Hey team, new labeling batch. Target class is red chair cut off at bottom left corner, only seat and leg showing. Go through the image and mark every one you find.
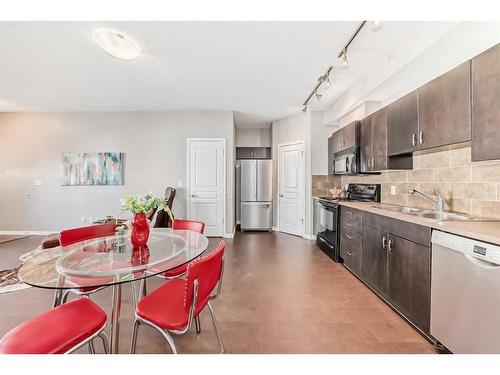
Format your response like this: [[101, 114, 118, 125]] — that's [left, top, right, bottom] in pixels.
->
[[0, 298, 109, 354]]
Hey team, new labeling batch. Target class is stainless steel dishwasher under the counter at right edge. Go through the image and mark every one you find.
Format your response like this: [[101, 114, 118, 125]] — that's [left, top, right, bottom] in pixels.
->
[[431, 230, 500, 353]]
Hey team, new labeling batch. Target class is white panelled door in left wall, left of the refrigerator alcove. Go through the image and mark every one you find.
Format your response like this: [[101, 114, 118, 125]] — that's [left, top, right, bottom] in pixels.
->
[[187, 139, 226, 237]]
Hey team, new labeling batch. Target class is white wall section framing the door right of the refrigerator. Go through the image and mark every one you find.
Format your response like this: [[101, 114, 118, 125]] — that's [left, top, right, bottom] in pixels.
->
[[272, 112, 312, 236]]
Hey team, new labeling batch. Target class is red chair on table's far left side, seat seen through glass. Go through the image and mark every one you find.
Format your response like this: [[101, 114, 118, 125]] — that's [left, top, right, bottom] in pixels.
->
[[60, 224, 116, 303]]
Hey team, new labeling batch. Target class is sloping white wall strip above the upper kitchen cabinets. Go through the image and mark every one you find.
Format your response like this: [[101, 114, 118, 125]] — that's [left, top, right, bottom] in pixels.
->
[[326, 22, 500, 123]]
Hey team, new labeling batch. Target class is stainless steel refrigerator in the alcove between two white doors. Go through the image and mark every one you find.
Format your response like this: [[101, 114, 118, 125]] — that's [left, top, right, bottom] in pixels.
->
[[240, 160, 273, 231]]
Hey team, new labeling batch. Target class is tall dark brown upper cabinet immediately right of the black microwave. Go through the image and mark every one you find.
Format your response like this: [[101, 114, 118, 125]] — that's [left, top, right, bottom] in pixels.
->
[[360, 107, 387, 172]]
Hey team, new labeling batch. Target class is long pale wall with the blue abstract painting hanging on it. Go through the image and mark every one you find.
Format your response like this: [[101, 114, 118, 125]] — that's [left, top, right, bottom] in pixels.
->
[[0, 112, 234, 233]]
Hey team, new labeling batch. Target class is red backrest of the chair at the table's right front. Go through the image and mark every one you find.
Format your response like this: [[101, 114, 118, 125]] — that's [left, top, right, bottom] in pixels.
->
[[184, 241, 226, 311]]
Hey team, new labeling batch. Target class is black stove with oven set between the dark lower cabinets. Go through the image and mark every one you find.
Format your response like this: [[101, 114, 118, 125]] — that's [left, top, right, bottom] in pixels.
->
[[314, 184, 380, 262]]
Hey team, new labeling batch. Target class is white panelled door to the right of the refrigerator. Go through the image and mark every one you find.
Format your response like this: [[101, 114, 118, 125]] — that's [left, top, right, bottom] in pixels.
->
[[278, 143, 305, 236]]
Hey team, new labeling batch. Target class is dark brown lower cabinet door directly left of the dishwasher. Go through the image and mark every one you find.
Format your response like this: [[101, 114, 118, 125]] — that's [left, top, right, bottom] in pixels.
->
[[388, 235, 431, 333]]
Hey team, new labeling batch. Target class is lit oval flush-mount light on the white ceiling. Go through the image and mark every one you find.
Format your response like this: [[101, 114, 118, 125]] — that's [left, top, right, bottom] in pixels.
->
[[94, 29, 141, 60]]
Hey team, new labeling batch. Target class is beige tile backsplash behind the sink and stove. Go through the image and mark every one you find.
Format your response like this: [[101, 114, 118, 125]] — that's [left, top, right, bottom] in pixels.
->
[[342, 147, 500, 219]]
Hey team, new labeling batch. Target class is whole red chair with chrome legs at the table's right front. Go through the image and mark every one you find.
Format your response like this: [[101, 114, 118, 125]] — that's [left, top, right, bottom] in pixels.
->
[[130, 241, 225, 354]]
